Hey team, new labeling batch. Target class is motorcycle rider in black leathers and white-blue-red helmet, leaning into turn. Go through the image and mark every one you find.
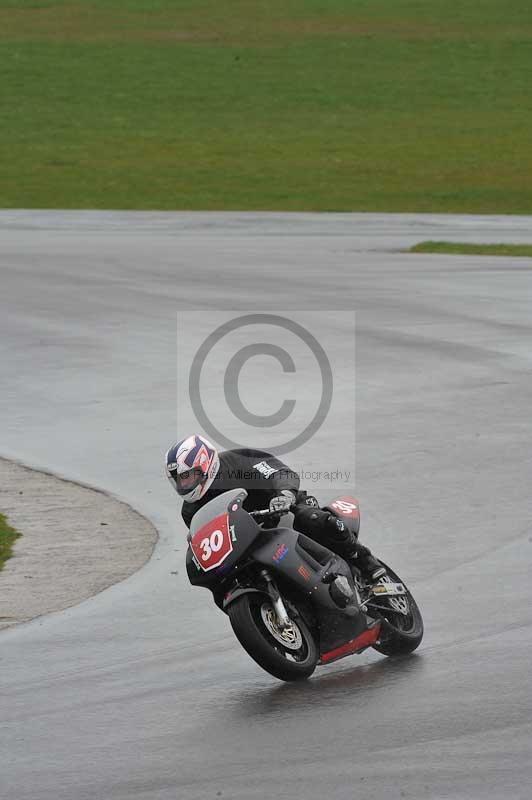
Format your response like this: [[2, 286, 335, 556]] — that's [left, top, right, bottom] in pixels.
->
[[166, 434, 386, 582]]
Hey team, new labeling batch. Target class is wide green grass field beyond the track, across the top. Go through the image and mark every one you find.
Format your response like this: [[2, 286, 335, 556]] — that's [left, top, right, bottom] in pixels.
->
[[0, 0, 532, 213]]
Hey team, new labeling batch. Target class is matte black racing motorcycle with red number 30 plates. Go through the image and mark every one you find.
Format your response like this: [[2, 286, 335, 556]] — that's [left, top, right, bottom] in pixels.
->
[[186, 489, 423, 681]]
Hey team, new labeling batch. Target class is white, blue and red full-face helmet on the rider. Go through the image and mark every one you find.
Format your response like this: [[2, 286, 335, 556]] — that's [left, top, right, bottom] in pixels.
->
[[166, 433, 220, 503]]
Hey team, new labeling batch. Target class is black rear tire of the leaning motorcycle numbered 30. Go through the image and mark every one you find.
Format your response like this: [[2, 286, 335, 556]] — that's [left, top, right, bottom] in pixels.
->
[[373, 565, 423, 656]]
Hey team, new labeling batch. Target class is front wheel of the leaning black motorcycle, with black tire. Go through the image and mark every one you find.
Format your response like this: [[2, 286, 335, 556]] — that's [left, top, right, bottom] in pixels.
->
[[227, 592, 319, 681]]
